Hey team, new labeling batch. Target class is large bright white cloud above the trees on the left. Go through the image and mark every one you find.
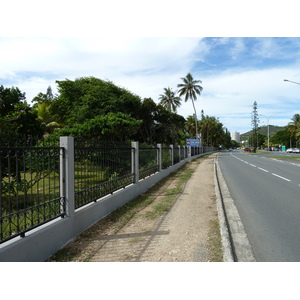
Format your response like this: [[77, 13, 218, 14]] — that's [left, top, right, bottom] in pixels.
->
[[0, 37, 204, 101]]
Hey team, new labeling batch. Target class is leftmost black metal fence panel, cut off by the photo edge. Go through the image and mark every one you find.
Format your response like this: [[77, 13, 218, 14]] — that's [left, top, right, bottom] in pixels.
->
[[0, 139, 65, 243]]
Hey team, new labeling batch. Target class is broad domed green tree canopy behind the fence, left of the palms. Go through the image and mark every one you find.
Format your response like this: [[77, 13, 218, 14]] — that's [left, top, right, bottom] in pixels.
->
[[51, 77, 185, 144]]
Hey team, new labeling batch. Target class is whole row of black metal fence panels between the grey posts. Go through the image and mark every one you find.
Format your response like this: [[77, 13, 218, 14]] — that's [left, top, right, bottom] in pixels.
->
[[0, 135, 214, 243]]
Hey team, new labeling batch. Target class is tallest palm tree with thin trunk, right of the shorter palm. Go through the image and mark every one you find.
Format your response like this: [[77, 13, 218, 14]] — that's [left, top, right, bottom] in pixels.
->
[[177, 73, 203, 144]]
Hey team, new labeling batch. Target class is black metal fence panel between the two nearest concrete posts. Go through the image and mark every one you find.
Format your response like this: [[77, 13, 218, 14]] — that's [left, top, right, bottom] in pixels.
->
[[74, 141, 134, 208]]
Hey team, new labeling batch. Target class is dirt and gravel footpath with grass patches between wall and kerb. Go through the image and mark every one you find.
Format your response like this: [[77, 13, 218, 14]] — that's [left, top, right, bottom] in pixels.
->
[[48, 156, 222, 262]]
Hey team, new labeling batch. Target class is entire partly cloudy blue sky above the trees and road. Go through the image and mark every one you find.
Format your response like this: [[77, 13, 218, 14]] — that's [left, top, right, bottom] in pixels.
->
[[0, 37, 300, 133]]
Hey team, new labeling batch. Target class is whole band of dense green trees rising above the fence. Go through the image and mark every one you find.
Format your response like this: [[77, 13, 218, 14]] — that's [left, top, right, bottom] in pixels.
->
[[0, 77, 230, 147]]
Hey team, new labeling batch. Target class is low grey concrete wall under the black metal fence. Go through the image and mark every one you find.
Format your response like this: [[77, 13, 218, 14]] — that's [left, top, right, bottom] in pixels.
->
[[0, 153, 207, 262]]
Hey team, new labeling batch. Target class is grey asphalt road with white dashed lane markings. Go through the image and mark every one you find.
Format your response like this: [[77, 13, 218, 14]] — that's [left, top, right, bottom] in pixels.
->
[[218, 151, 300, 262]]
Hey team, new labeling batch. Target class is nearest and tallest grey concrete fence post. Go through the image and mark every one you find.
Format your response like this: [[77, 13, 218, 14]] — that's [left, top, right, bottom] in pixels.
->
[[59, 136, 75, 218]]
